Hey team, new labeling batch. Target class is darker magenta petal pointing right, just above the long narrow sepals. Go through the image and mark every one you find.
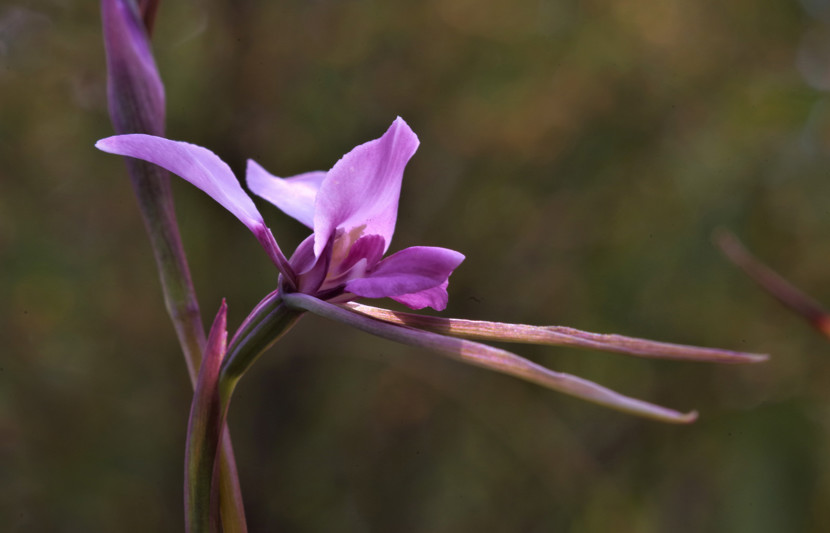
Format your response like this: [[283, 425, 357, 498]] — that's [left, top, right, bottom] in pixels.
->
[[346, 246, 464, 298]]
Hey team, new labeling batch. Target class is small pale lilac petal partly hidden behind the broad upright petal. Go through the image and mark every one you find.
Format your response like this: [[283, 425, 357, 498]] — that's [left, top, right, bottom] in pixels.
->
[[245, 159, 326, 229]]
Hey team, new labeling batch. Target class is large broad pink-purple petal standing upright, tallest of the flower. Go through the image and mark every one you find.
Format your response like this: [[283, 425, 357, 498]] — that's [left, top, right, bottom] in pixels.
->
[[314, 117, 418, 257]]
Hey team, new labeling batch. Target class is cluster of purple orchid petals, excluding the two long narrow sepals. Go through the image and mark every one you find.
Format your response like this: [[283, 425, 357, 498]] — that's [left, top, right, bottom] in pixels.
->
[[95, 117, 464, 311]]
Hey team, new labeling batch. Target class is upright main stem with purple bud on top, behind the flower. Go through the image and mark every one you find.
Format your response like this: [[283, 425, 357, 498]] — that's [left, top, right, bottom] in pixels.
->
[[101, 0, 247, 532]]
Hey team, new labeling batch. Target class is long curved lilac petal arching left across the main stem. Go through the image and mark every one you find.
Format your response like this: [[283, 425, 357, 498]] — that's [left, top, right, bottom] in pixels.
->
[[95, 134, 296, 284]]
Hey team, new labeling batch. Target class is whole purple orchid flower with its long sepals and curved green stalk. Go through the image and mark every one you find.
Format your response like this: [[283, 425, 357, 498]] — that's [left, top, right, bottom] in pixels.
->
[[96, 118, 766, 423]]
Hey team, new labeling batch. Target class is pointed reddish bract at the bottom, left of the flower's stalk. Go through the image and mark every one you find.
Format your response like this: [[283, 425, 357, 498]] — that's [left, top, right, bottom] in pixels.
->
[[184, 300, 228, 533]]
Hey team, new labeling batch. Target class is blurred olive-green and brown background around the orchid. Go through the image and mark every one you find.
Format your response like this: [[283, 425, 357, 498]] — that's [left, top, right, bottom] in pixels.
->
[[0, 0, 830, 533]]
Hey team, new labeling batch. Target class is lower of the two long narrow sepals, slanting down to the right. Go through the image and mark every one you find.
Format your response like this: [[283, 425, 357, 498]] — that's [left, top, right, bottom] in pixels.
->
[[283, 293, 697, 423]]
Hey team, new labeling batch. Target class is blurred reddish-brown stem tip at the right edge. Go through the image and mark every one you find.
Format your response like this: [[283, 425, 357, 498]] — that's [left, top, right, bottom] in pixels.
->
[[713, 230, 830, 338]]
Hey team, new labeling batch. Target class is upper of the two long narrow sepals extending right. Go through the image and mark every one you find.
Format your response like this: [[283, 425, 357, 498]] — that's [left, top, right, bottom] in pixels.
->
[[345, 303, 768, 363]]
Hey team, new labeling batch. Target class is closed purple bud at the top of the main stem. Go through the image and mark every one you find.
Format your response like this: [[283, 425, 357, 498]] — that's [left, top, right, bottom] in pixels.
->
[[101, 0, 165, 135]]
